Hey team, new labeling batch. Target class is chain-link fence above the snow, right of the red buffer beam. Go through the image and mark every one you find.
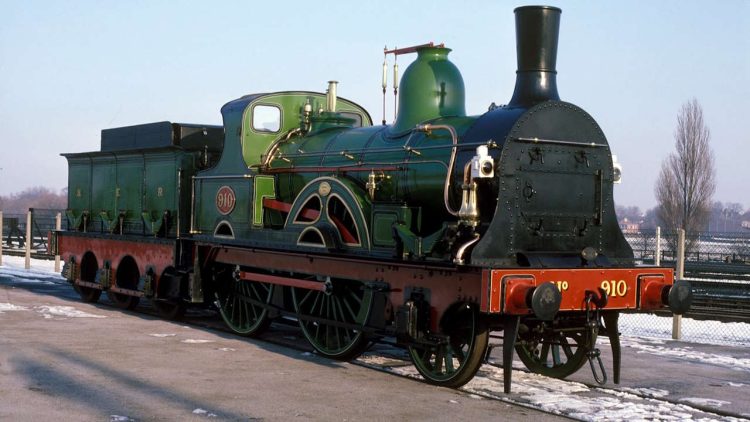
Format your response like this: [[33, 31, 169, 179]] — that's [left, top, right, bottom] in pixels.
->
[[620, 230, 750, 345]]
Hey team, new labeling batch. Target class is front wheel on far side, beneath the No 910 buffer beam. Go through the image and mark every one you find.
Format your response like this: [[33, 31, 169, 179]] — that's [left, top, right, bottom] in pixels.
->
[[516, 322, 596, 378]]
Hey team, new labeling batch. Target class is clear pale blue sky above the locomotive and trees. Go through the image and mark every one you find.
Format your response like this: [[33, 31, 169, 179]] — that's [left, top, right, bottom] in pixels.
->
[[0, 0, 750, 209]]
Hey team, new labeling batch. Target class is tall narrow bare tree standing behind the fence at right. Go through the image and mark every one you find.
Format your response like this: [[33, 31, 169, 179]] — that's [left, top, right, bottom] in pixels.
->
[[655, 98, 716, 244]]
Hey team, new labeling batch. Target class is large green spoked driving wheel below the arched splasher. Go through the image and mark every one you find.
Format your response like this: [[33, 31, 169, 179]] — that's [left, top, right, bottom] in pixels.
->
[[292, 280, 373, 360]]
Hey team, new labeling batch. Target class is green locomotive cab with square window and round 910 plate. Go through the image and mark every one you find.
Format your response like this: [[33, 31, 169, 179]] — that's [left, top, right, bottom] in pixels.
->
[[191, 90, 372, 240]]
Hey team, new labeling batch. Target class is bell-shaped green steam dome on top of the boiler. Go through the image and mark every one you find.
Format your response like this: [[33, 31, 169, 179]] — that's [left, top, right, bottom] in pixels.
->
[[393, 47, 466, 133]]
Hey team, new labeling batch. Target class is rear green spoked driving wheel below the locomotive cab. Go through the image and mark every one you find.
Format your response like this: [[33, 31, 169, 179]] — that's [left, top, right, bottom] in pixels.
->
[[216, 267, 274, 337]]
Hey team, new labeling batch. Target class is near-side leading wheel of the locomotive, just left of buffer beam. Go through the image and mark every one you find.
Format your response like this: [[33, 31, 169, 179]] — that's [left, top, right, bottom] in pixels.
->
[[409, 304, 489, 388]]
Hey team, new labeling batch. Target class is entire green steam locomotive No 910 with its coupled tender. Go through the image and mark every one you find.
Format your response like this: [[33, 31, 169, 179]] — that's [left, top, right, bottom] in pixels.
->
[[54, 6, 691, 391]]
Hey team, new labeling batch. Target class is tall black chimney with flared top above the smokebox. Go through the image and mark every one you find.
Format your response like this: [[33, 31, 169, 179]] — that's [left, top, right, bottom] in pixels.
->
[[508, 6, 562, 107]]
